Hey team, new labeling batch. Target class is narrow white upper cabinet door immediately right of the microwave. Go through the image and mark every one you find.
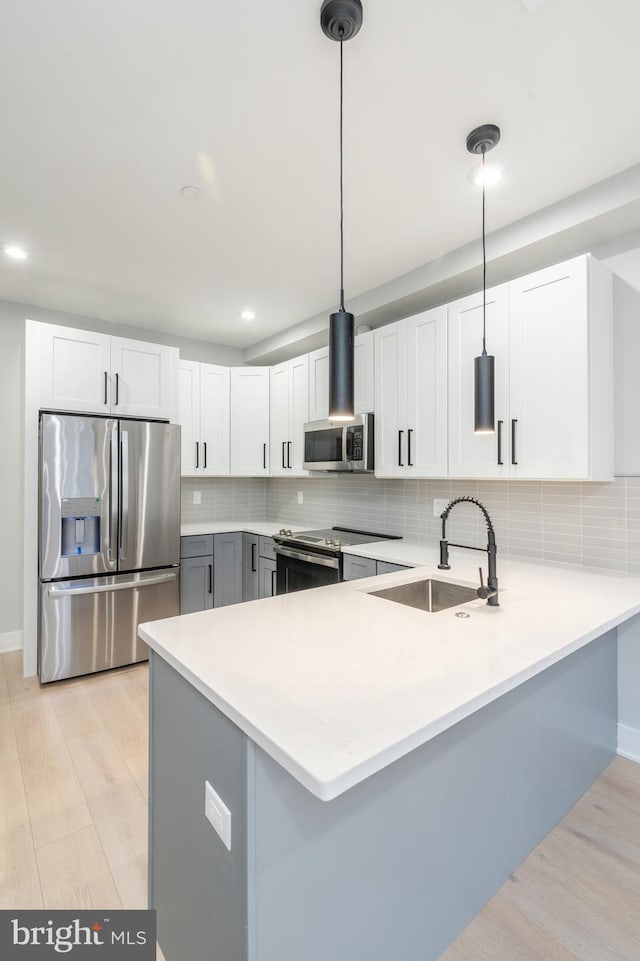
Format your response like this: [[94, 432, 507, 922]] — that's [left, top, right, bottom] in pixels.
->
[[375, 320, 407, 477]]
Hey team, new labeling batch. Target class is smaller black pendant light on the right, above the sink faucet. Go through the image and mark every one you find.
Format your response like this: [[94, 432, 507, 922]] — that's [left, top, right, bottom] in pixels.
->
[[467, 123, 500, 434]]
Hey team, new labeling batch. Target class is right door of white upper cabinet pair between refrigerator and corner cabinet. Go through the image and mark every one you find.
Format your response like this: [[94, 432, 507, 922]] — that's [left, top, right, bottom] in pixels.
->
[[200, 364, 229, 477]]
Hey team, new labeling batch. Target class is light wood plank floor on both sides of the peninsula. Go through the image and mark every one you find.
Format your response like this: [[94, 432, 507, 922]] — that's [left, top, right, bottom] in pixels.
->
[[0, 652, 640, 961]]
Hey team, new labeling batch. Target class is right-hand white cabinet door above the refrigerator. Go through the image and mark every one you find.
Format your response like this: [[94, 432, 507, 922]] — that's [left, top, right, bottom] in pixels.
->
[[111, 337, 178, 419]]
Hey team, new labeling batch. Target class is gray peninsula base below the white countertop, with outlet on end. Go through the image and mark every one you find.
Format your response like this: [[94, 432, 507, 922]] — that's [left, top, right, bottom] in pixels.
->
[[149, 631, 617, 961]]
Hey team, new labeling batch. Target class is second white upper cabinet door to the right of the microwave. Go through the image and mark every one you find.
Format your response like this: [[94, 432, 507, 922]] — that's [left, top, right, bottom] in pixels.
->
[[403, 306, 447, 477]]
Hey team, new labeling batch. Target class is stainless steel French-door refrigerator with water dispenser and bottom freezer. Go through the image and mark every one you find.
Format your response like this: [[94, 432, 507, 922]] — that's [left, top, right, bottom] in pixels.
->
[[38, 413, 180, 683]]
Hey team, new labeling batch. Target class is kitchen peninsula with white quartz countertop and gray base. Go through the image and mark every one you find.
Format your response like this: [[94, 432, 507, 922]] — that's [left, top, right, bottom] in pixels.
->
[[140, 542, 640, 961]]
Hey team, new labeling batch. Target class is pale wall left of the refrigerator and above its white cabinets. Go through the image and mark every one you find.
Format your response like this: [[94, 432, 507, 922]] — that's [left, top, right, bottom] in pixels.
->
[[0, 300, 243, 651]]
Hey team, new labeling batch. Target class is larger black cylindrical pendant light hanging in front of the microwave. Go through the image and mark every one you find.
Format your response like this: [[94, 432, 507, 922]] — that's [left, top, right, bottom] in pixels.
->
[[320, 0, 362, 420]]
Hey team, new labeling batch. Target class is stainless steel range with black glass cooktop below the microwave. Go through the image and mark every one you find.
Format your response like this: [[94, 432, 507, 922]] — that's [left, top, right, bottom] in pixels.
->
[[274, 527, 400, 594]]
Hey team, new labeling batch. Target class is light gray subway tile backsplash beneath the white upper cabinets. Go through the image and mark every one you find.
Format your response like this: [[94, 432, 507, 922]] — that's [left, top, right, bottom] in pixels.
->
[[182, 474, 640, 574]]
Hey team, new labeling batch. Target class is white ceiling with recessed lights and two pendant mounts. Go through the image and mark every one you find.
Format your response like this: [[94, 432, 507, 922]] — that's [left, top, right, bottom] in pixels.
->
[[0, 0, 640, 347]]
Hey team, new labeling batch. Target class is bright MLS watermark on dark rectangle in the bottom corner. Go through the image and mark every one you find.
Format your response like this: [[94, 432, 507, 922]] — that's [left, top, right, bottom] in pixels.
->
[[0, 910, 156, 961]]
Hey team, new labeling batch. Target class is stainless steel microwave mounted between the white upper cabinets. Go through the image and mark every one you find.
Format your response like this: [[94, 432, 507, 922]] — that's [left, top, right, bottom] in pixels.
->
[[302, 414, 374, 472]]
